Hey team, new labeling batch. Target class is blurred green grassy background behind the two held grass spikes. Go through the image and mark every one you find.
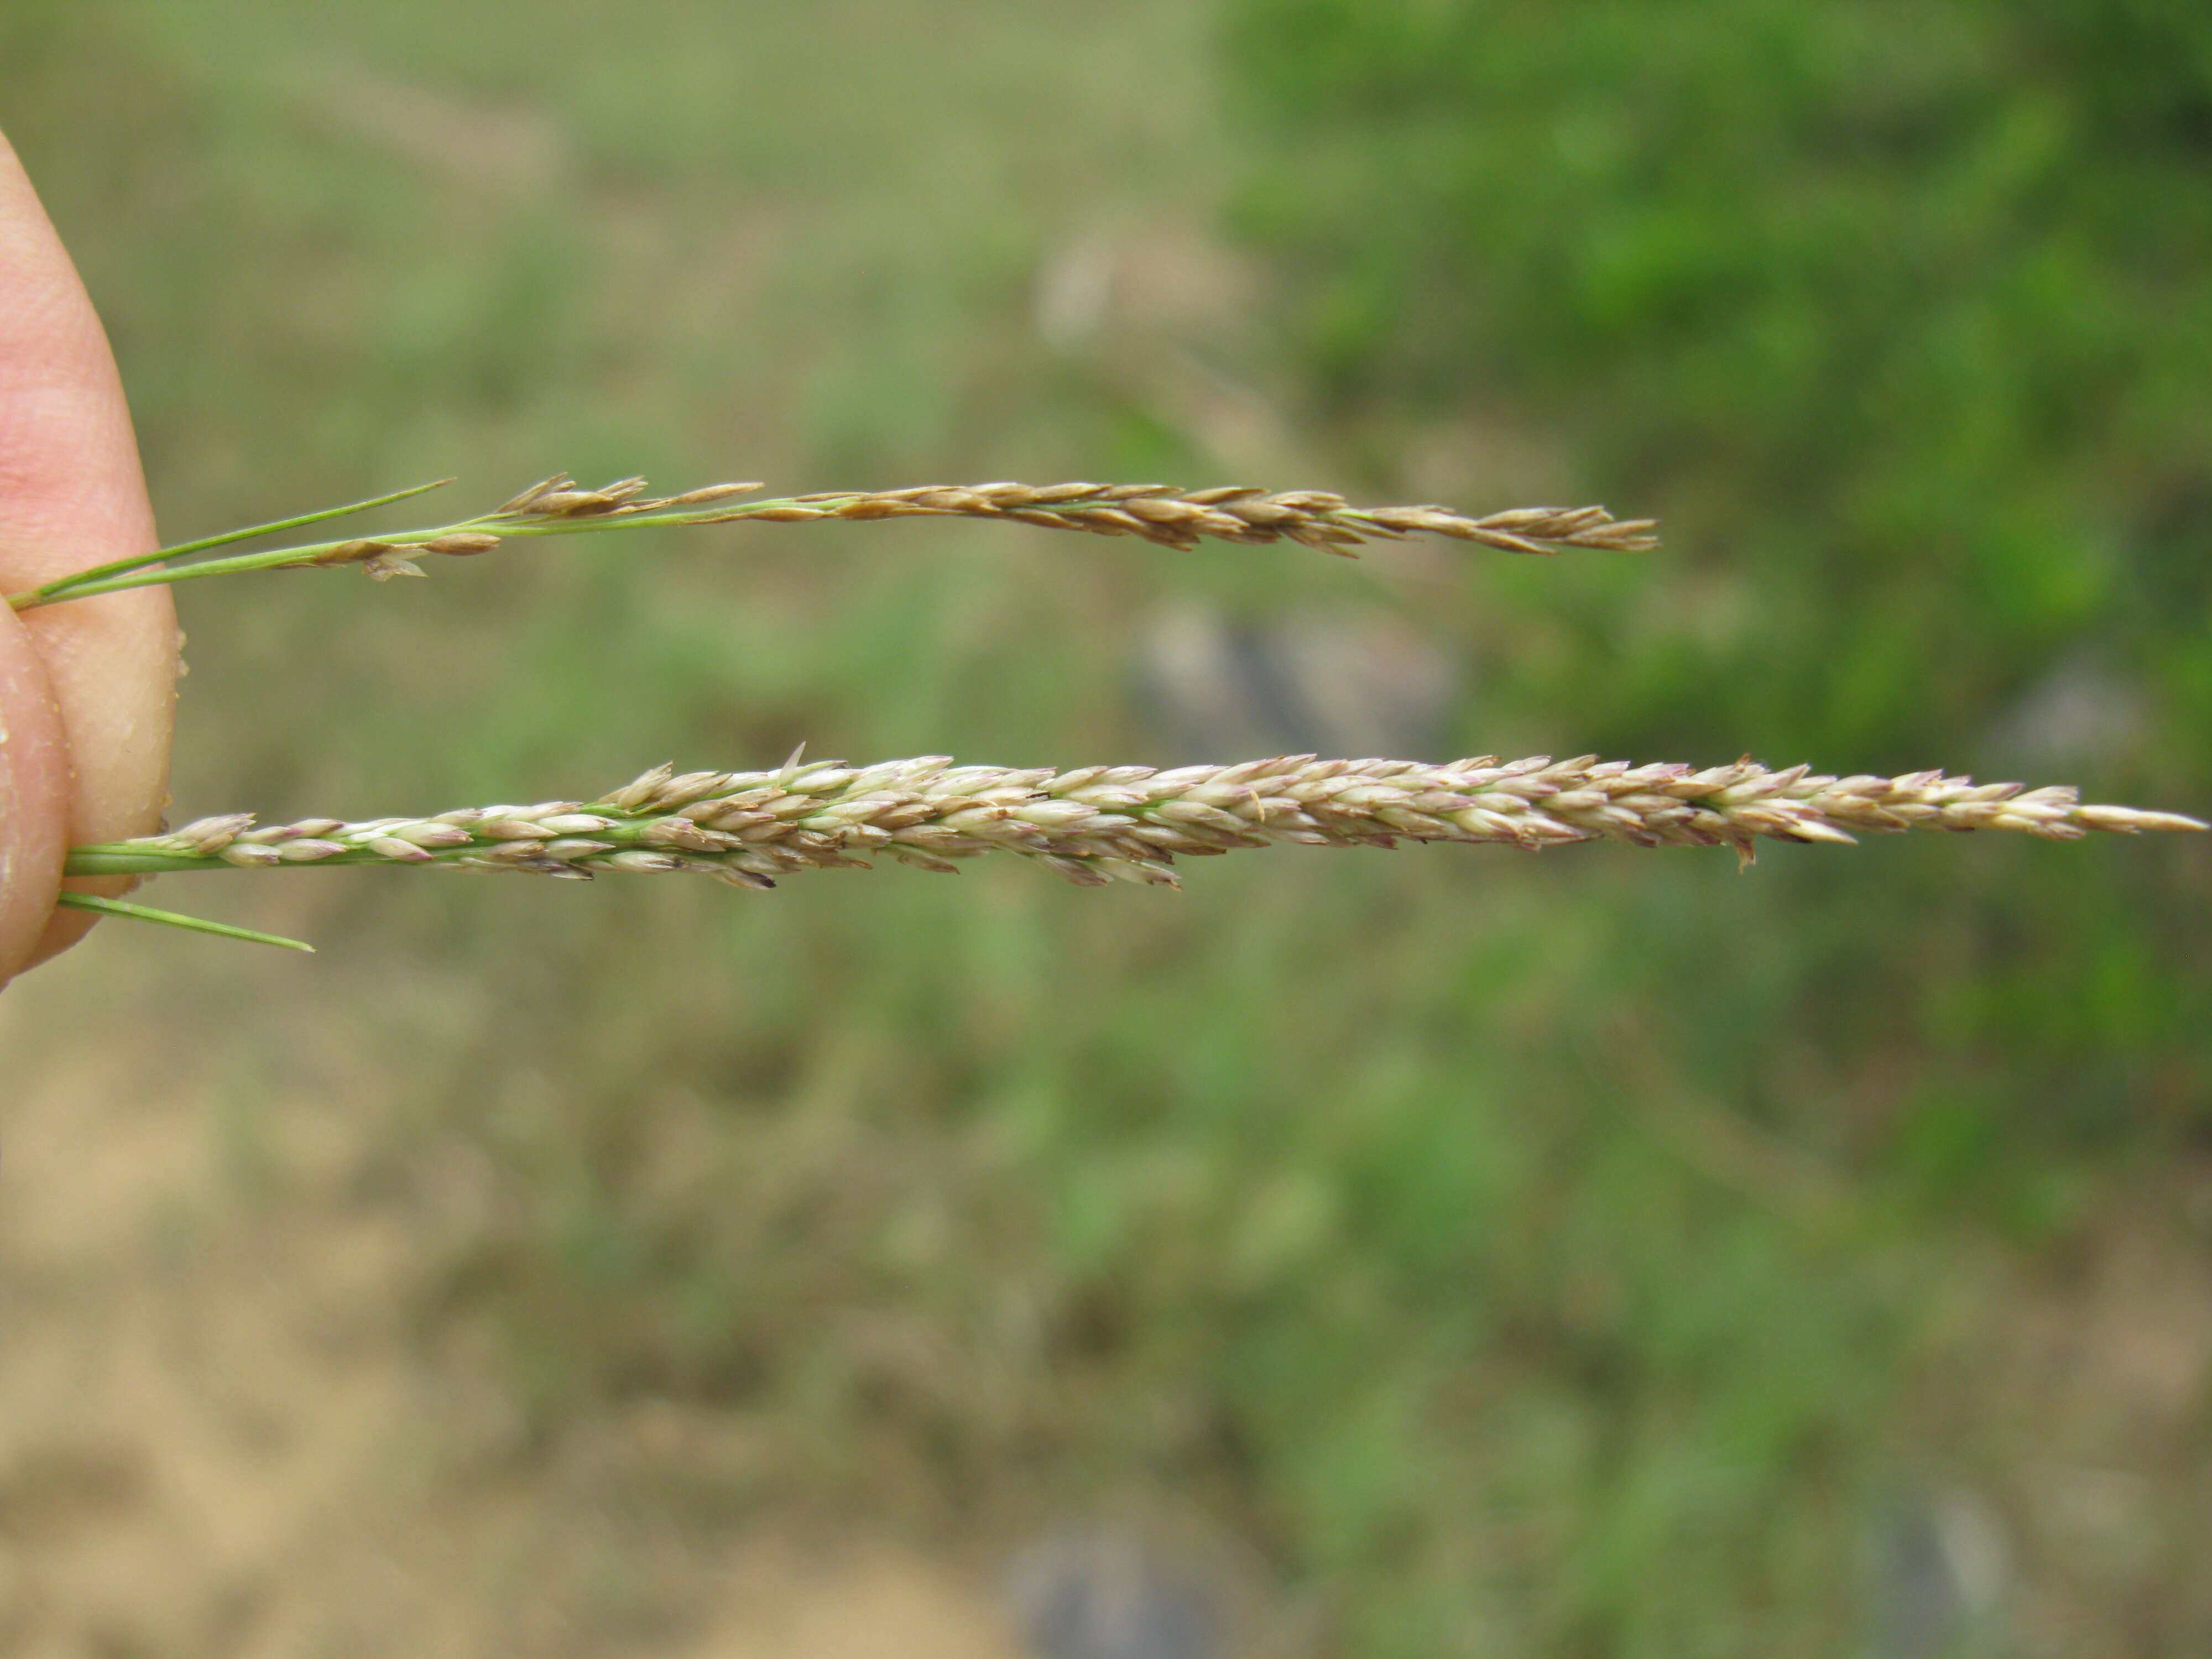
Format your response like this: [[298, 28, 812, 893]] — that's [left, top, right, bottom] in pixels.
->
[[0, 0, 2212, 1657]]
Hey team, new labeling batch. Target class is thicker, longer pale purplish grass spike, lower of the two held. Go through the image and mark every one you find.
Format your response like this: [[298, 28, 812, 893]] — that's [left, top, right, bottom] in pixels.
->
[[69, 754, 2205, 902]]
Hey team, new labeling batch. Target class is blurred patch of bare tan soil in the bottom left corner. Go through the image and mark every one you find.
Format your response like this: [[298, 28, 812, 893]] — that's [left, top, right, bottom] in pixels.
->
[[0, 980, 1020, 1659]]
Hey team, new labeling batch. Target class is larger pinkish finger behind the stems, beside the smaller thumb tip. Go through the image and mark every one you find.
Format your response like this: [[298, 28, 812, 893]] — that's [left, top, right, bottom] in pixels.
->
[[0, 137, 177, 982]]
